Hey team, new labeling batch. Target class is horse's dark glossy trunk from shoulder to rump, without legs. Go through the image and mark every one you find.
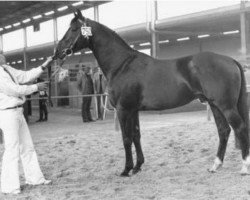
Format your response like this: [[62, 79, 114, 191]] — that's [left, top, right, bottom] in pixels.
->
[[110, 52, 240, 110]]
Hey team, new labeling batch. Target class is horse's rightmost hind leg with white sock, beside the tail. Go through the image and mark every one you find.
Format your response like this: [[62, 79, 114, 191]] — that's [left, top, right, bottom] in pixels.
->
[[225, 109, 250, 175]]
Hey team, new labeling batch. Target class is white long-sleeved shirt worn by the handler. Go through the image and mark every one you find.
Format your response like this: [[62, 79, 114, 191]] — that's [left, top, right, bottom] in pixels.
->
[[0, 65, 43, 110]]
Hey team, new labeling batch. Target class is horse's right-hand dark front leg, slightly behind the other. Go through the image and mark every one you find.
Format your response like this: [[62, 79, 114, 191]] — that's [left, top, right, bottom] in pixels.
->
[[133, 112, 144, 174]]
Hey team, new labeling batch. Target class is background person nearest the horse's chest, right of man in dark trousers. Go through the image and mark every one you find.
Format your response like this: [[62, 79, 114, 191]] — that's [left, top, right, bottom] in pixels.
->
[[93, 67, 107, 119]]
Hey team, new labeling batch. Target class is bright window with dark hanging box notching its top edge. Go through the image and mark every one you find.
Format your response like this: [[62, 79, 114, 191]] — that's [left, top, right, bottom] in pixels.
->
[[27, 20, 54, 47]]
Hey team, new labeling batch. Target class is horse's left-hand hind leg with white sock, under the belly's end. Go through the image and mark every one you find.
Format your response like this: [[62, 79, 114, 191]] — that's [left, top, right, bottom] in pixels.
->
[[209, 104, 231, 172]]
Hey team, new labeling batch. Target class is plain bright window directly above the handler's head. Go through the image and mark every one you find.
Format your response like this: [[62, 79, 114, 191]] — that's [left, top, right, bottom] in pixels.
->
[[3, 29, 24, 51]]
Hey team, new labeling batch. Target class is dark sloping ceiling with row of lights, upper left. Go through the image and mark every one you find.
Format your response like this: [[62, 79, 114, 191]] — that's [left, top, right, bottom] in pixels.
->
[[0, 1, 109, 34]]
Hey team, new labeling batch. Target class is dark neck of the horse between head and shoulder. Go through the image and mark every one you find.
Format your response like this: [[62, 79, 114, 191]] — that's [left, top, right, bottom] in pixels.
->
[[89, 25, 134, 79]]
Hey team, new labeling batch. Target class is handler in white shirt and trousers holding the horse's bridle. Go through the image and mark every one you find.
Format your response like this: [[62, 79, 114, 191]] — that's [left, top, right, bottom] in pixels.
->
[[0, 54, 52, 194]]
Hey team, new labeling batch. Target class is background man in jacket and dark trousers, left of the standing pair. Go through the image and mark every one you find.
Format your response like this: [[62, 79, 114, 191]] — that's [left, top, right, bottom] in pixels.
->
[[77, 65, 94, 122]]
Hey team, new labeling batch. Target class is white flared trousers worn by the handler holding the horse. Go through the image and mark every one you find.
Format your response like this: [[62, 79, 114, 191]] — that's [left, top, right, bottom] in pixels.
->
[[0, 108, 45, 193]]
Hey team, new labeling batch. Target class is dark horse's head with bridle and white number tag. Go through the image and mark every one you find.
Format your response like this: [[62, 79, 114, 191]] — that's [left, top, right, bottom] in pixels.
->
[[54, 9, 92, 60]]
